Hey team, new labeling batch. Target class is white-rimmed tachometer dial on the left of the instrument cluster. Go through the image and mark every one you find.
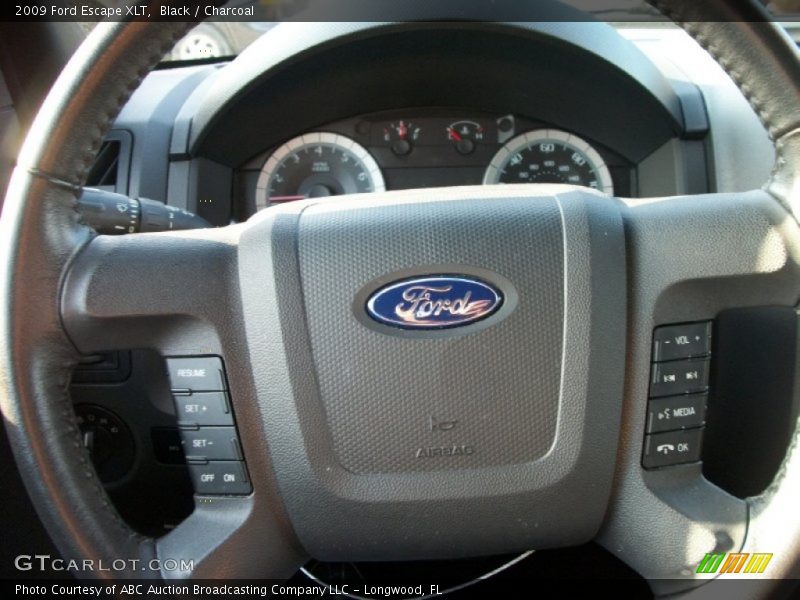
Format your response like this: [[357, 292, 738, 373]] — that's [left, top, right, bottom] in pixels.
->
[[256, 132, 385, 210]]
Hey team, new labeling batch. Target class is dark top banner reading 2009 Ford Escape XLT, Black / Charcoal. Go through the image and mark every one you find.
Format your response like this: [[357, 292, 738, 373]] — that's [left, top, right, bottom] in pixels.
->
[[0, 0, 800, 23]]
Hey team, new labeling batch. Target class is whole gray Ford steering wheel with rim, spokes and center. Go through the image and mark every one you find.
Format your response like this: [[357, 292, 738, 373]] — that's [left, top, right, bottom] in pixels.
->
[[0, 0, 800, 596]]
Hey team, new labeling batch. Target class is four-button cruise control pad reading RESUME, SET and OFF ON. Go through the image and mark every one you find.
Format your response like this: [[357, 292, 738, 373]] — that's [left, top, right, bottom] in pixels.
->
[[167, 356, 252, 495]]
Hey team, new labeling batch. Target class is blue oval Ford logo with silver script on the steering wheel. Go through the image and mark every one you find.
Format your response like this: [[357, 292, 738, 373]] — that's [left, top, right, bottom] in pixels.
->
[[367, 275, 503, 329]]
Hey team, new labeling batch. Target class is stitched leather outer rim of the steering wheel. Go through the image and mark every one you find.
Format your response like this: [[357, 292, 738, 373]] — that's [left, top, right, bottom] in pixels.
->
[[0, 0, 800, 594]]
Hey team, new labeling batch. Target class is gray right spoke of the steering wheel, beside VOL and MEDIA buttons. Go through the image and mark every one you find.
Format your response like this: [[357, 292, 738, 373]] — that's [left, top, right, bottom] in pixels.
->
[[598, 191, 800, 594]]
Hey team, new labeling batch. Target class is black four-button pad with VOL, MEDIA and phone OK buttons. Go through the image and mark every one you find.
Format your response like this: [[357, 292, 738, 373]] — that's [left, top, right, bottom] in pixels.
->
[[642, 321, 712, 469]]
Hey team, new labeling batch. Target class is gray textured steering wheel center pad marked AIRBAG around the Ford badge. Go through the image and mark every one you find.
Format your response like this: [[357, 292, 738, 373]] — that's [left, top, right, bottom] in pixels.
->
[[240, 186, 625, 560]]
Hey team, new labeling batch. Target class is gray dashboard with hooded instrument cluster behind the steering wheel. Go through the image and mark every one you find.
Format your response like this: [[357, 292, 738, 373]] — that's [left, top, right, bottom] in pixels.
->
[[106, 22, 772, 225]]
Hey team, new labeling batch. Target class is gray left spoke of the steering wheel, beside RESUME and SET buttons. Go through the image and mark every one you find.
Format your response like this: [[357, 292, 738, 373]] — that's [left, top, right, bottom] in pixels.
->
[[61, 227, 304, 579]]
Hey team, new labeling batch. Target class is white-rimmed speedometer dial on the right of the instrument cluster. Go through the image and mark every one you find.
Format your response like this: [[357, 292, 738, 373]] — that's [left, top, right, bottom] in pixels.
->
[[483, 129, 614, 195]]
